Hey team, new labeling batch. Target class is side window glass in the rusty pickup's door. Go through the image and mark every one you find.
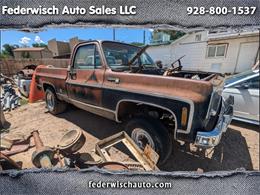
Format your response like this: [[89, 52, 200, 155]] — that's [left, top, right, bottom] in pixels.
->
[[74, 44, 102, 69]]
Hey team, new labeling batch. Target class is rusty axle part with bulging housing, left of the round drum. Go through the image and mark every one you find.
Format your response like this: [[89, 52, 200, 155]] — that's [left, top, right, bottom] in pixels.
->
[[32, 130, 54, 168]]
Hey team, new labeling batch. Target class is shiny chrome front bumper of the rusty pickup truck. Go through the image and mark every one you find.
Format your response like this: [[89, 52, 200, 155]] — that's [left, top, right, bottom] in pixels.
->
[[195, 96, 234, 148]]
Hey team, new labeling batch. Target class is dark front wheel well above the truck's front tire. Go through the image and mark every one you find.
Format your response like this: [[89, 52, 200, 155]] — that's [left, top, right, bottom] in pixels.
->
[[116, 101, 177, 133]]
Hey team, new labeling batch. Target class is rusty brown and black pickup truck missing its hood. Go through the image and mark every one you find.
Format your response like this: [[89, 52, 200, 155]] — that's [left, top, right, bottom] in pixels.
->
[[36, 41, 233, 164]]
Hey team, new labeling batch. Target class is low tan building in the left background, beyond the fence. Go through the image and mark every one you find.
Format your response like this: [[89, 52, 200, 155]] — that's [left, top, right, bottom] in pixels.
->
[[13, 47, 52, 59]]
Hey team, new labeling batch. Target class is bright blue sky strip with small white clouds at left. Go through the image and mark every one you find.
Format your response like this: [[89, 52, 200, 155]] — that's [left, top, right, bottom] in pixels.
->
[[1, 27, 151, 46]]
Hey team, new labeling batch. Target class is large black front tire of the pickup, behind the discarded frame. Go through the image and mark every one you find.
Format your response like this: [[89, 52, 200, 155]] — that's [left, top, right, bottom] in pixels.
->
[[125, 117, 172, 166]]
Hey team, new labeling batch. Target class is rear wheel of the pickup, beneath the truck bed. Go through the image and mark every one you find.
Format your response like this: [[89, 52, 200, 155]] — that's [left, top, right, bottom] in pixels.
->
[[45, 88, 67, 115]]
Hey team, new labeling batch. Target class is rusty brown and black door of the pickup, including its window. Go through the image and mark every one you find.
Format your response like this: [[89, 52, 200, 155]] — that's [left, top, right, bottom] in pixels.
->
[[66, 43, 104, 106]]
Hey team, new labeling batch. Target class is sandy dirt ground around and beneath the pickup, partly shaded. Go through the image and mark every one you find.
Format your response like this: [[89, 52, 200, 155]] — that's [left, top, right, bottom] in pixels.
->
[[1, 102, 259, 171]]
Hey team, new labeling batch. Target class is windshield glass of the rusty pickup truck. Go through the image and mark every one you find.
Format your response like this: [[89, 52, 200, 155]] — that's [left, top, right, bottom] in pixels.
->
[[102, 42, 156, 70]]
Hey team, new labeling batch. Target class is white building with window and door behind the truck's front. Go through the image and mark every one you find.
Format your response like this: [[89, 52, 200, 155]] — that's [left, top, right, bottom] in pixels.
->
[[147, 31, 259, 73]]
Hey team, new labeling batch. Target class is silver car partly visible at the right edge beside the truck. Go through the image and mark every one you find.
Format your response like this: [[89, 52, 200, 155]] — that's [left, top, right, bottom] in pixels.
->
[[223, 69, 260, 125]]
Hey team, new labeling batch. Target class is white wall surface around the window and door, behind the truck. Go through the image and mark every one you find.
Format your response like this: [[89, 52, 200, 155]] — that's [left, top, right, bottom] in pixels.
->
[[147, 31, 259, 73]]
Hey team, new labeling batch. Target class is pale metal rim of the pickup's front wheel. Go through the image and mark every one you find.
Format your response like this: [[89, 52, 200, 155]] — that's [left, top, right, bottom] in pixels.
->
[[131, 128, 155, 150]]
